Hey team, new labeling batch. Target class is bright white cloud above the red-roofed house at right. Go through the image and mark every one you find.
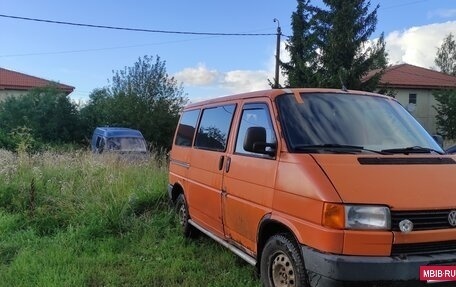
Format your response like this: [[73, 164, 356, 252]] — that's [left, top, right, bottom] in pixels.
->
[[385, 21, 456, 68]]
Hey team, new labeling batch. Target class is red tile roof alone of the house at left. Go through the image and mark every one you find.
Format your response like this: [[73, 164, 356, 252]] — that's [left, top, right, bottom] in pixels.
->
[[0, 68, 74, 94]]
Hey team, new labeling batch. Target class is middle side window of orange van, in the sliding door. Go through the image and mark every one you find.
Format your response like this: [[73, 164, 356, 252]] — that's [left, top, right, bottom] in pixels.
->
[[195, 104, 236, 151]]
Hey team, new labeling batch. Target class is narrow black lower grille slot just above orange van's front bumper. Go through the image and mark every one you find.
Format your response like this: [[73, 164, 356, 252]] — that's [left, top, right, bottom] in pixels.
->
[[391, 241, 456, 256]]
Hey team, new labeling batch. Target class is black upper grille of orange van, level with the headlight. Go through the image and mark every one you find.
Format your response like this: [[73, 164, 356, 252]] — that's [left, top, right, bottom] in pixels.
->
[[391, 209, 454, 231]]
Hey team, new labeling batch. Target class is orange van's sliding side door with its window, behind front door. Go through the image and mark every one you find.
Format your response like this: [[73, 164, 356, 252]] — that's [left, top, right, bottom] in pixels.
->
[[187, 104, 236, 237]]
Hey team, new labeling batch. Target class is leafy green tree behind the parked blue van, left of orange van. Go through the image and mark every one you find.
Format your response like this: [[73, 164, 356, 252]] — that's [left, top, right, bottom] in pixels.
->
[[81, 56, 187, 151]]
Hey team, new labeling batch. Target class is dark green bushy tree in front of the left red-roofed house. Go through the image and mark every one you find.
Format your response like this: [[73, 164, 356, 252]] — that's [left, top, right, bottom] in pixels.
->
[[0, 86, 81, 146]]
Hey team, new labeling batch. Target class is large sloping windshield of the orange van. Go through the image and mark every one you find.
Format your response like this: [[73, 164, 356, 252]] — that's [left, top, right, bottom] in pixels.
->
[[276, 93, 443, 154]]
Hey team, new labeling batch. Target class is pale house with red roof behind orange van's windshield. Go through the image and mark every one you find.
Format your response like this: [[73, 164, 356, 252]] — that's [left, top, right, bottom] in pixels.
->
[[365, 64, 456, 134]]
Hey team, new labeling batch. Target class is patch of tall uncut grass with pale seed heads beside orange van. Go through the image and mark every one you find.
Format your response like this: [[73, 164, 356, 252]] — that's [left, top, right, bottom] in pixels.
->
[[0, 151, 166, 235]]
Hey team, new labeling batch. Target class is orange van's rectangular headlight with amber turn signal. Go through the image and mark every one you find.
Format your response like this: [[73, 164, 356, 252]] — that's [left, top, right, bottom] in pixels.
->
[[322, 203, 391, 230]]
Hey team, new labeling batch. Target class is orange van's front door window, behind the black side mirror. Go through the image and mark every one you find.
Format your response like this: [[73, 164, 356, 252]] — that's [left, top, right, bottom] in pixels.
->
[[234, 103, 277, 156]]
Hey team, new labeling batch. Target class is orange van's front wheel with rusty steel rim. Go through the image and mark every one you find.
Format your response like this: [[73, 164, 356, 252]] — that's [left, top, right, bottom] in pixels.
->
[[260, 234, 310, 287]]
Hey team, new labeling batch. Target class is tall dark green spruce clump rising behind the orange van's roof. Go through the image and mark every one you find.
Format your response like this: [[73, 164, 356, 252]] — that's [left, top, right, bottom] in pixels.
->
[[283, 0, 387, 91]]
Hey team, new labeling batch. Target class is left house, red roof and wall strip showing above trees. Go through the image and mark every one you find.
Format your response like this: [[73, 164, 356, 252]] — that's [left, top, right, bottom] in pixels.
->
[[0, 68, 74, 101]]
